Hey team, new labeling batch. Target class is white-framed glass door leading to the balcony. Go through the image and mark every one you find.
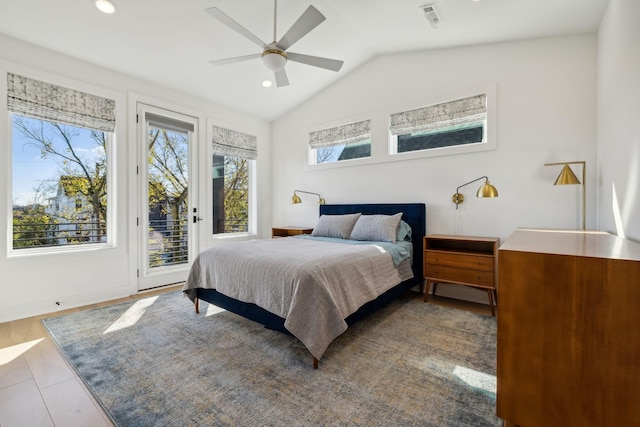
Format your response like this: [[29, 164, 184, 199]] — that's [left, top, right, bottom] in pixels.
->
[[138, 105, 198, 290]]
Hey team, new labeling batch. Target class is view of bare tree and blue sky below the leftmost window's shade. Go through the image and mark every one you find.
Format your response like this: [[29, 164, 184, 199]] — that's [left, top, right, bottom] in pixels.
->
[[12, 114, 111, 249]]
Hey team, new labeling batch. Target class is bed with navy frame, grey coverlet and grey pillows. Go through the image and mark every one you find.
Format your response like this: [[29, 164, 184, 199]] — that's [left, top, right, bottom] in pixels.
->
[[183, 203, 426, 368]]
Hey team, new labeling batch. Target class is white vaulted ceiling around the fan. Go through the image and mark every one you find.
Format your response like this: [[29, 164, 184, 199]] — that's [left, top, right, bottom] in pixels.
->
[[0, 0, 608, 121]]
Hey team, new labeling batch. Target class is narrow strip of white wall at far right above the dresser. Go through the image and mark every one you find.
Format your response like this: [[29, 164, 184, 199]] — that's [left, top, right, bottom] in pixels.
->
[[598, 0, 640, 241]]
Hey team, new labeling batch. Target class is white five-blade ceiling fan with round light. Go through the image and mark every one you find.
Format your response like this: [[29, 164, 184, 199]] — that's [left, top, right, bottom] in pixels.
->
[[205, 0, 344, 87]]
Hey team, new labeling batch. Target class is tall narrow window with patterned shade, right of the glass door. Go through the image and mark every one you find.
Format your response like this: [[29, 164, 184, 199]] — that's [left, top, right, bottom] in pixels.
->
[[212, 126, 258, 234]]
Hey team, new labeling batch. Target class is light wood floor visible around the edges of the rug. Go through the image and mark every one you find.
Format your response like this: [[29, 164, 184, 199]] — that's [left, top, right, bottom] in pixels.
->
[[0, 285, 491, 427]]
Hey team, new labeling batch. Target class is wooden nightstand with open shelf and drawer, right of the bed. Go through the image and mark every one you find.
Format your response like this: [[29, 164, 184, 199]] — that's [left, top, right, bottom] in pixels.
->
[[423, 234, 500, 316]]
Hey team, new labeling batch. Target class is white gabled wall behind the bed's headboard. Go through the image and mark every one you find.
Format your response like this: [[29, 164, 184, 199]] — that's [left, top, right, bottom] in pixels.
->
[[273, 35, 597, 301]]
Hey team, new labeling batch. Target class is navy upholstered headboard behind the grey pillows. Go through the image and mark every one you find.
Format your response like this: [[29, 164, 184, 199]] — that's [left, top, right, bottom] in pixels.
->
[[320, 203, 427, 283]]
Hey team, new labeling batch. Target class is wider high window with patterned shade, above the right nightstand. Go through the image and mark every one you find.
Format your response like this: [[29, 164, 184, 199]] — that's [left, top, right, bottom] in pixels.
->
[[390, 94, 487, 154]]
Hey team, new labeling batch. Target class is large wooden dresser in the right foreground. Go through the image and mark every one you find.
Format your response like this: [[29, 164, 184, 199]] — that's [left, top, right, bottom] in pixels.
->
[[497, 229, 640, 427]]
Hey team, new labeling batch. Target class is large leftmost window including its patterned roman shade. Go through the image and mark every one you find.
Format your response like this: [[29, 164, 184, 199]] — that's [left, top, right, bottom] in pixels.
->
[[7, 73, 115, 250]]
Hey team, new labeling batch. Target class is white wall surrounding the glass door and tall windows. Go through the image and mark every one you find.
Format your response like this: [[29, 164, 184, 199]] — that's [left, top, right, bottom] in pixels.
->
[[0, 35, 271, 322]]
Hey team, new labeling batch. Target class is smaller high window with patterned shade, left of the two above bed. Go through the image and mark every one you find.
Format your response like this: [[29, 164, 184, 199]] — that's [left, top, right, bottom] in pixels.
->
[[309, 120, 371, 164]]
